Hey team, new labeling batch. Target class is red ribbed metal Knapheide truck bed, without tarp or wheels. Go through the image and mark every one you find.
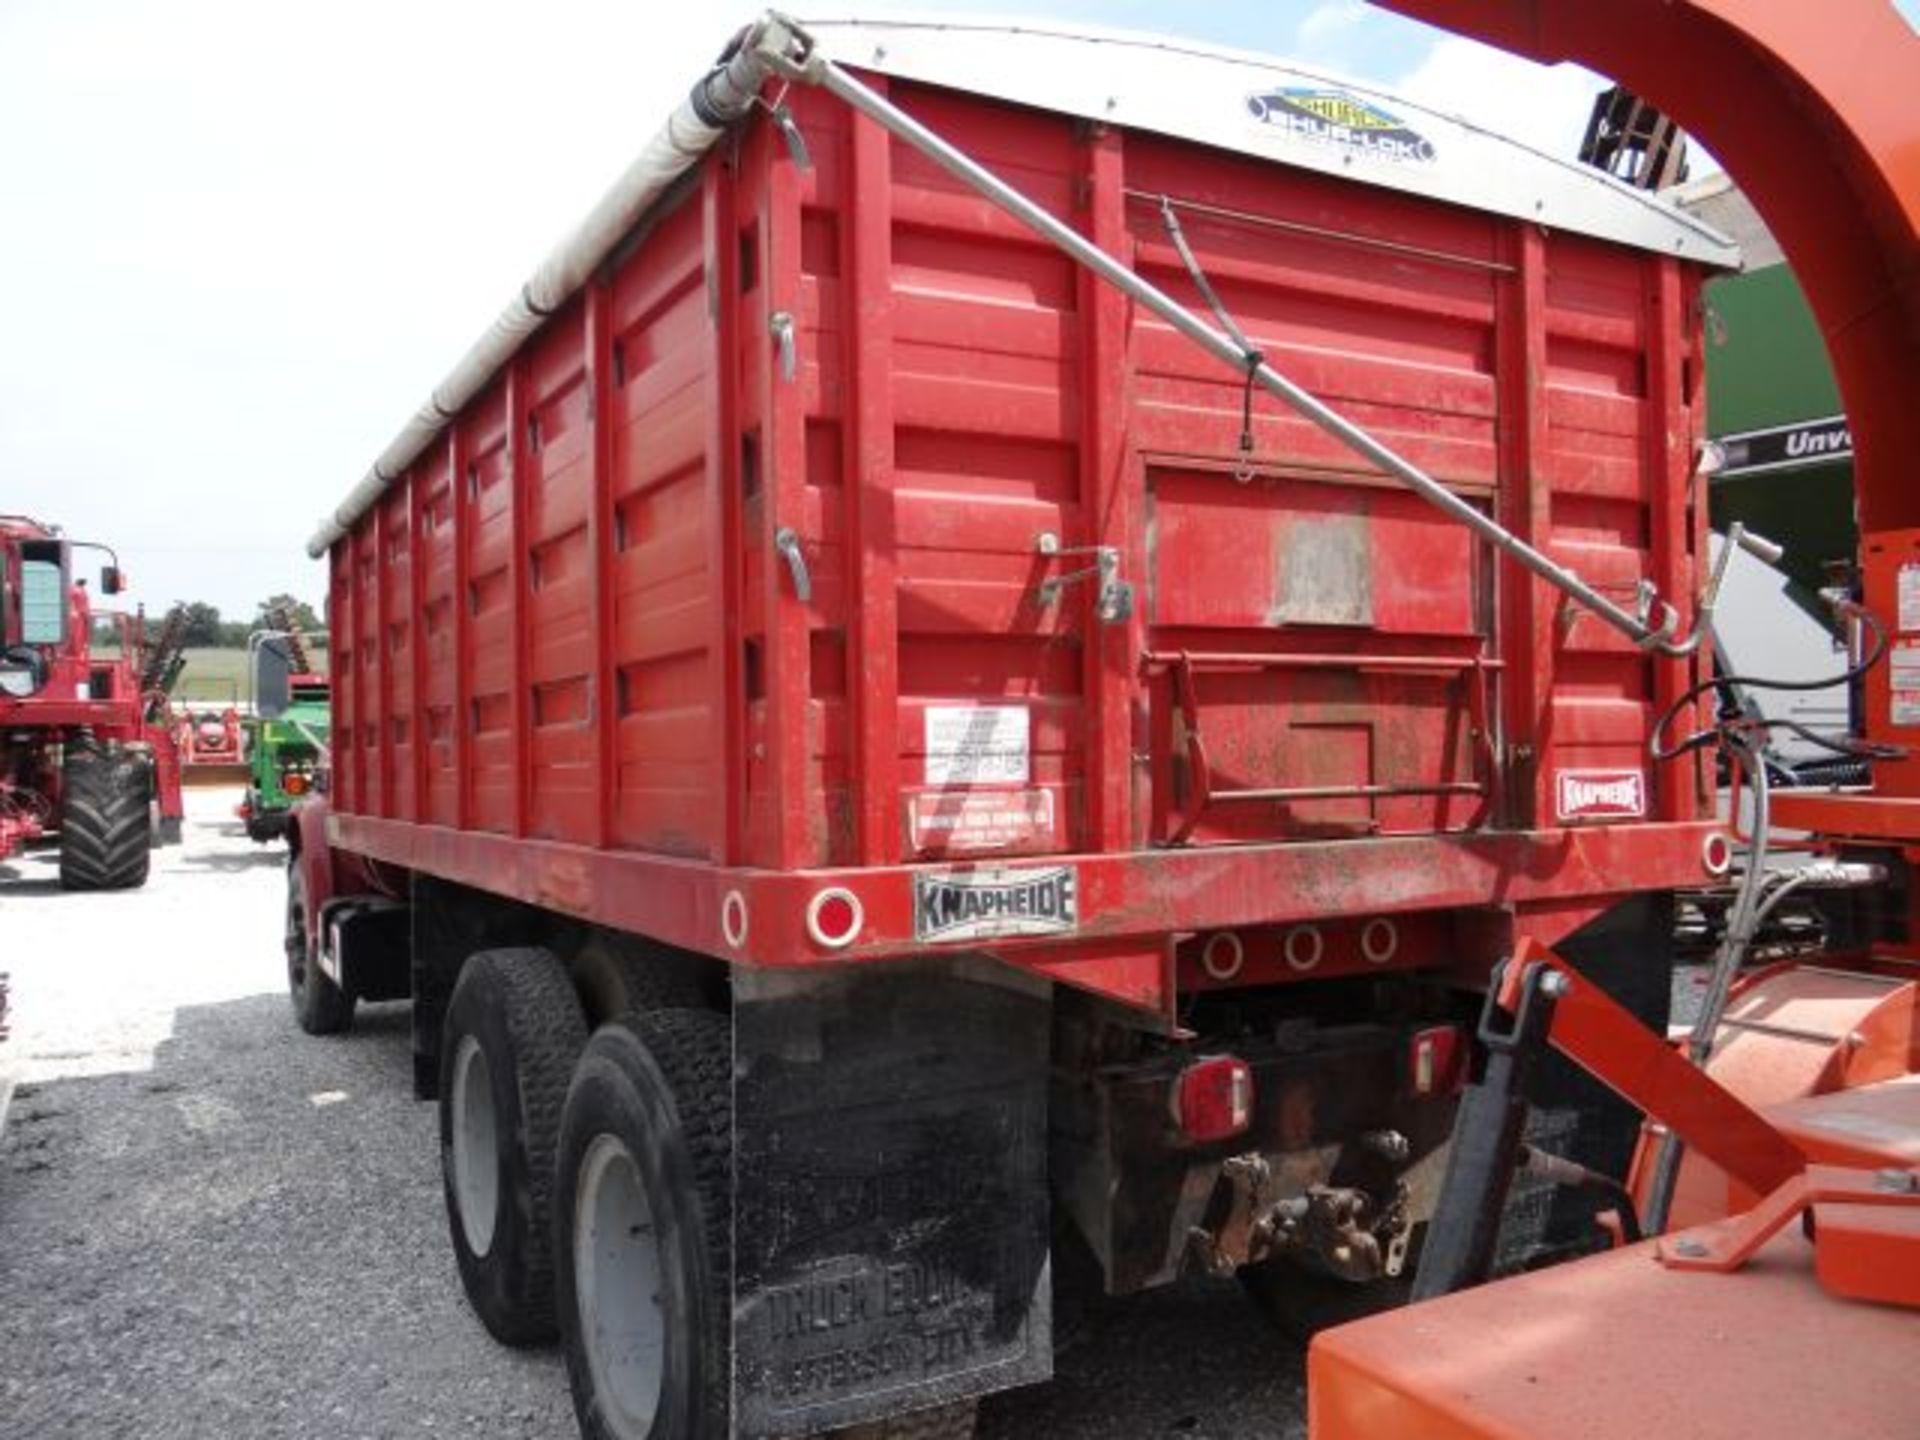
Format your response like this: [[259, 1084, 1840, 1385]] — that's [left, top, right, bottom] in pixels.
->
[[311, 16, 1728, 1006]]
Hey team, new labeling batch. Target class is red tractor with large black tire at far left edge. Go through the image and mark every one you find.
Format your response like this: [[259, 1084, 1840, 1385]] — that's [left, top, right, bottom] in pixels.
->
[[0, 515, 180, 891]]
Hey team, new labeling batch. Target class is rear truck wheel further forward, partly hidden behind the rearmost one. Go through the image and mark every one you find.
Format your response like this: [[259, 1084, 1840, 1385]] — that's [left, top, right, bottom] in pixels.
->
[[440, 947, 588, 1346]]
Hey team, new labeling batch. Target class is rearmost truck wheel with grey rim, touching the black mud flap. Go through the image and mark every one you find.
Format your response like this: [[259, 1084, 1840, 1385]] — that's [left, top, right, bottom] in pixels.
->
[[553, 1010, 733, 1440]]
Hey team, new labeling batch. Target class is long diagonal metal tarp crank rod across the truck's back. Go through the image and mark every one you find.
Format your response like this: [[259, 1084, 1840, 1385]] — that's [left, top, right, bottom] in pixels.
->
[[756, 13, 1780, 659]]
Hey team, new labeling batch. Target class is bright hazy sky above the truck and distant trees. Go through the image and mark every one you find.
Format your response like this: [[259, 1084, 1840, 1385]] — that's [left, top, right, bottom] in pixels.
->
[[0, 0, 1920, 618]]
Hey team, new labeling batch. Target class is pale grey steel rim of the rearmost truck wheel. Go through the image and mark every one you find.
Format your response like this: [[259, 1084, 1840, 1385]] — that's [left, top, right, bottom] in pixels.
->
[[574, 1135, 666, 1440]]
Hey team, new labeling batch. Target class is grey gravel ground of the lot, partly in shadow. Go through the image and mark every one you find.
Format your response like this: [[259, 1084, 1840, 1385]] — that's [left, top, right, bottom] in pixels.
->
[[0, 791, 1304, 1440]]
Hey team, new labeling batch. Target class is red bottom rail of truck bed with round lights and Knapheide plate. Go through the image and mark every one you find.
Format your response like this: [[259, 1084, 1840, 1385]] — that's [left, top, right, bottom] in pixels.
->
[[326, 812, 1718, 1010]]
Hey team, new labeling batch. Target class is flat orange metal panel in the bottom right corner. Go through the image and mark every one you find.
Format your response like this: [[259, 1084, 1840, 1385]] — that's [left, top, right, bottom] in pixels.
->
[[1308, 1227, 1920, 1440]]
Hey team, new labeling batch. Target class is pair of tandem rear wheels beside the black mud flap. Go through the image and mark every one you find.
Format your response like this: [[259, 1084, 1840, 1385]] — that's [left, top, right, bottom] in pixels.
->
[[440, 948, 973, 1440]]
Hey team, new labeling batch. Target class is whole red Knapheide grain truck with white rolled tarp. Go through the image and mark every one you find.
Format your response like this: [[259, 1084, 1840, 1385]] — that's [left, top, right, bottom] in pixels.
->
[[286, 17, 1736, 1436]]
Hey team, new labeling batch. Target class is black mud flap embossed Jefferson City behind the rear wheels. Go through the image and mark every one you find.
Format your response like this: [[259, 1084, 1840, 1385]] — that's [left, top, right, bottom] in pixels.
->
[[733, 960, 1052, 1436]]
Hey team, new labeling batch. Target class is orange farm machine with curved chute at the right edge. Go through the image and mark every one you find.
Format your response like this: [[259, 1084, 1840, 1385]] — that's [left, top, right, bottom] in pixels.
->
[[1309, 0, 1920, 1440]]
